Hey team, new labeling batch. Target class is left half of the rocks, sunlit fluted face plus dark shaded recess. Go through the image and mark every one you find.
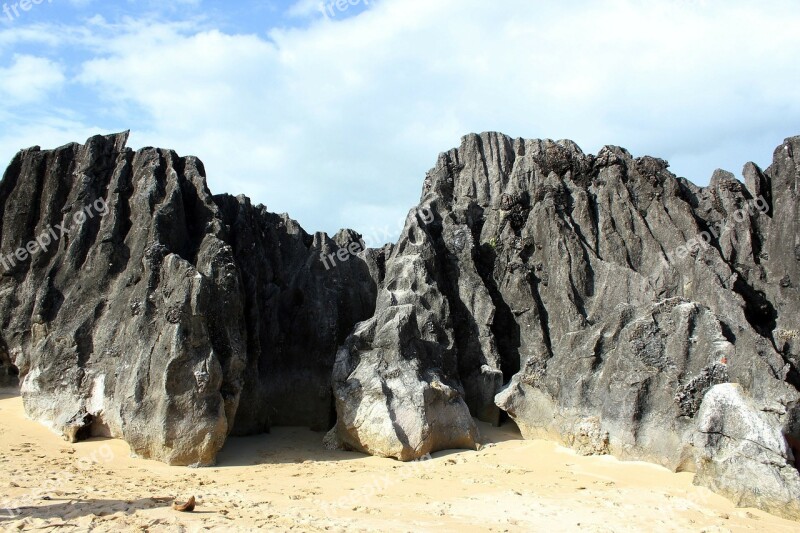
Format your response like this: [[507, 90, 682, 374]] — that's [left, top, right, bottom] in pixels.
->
[[0, 134, 374, 465]]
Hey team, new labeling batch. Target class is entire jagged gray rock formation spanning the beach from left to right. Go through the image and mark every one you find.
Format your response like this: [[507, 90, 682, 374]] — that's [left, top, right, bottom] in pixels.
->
[[0, 133, 800, 519]]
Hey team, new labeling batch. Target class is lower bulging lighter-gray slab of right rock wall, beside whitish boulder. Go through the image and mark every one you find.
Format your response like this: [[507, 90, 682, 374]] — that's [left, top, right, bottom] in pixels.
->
[[497, 298, 796, 471]]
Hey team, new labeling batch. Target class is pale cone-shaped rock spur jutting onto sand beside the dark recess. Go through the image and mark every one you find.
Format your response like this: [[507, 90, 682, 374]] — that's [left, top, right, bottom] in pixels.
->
[[333, 216, 477, 461]]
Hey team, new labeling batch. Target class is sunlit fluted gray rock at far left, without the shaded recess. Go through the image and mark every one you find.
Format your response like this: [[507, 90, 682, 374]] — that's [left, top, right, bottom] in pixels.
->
[[0, 134, 245, 464]]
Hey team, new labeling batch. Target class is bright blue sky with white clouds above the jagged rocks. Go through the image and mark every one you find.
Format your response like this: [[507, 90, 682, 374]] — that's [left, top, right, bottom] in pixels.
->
[[0, 0, 800, 246]]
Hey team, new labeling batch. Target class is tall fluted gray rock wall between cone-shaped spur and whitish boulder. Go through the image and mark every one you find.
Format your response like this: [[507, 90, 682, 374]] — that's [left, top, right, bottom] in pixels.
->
[[386, 133, 800, 516]]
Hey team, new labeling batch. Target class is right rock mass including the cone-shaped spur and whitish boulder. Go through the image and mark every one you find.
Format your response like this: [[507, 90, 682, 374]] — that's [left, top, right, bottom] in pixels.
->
[[326, 134, 800, 518]]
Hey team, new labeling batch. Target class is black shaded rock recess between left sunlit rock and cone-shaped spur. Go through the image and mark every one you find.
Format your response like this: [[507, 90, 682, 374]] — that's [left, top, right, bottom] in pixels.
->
[[215, 196, 378, 435]]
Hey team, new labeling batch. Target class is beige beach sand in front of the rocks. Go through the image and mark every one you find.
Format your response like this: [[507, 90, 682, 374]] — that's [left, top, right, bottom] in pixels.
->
[[0, 391, 800, 532]]
